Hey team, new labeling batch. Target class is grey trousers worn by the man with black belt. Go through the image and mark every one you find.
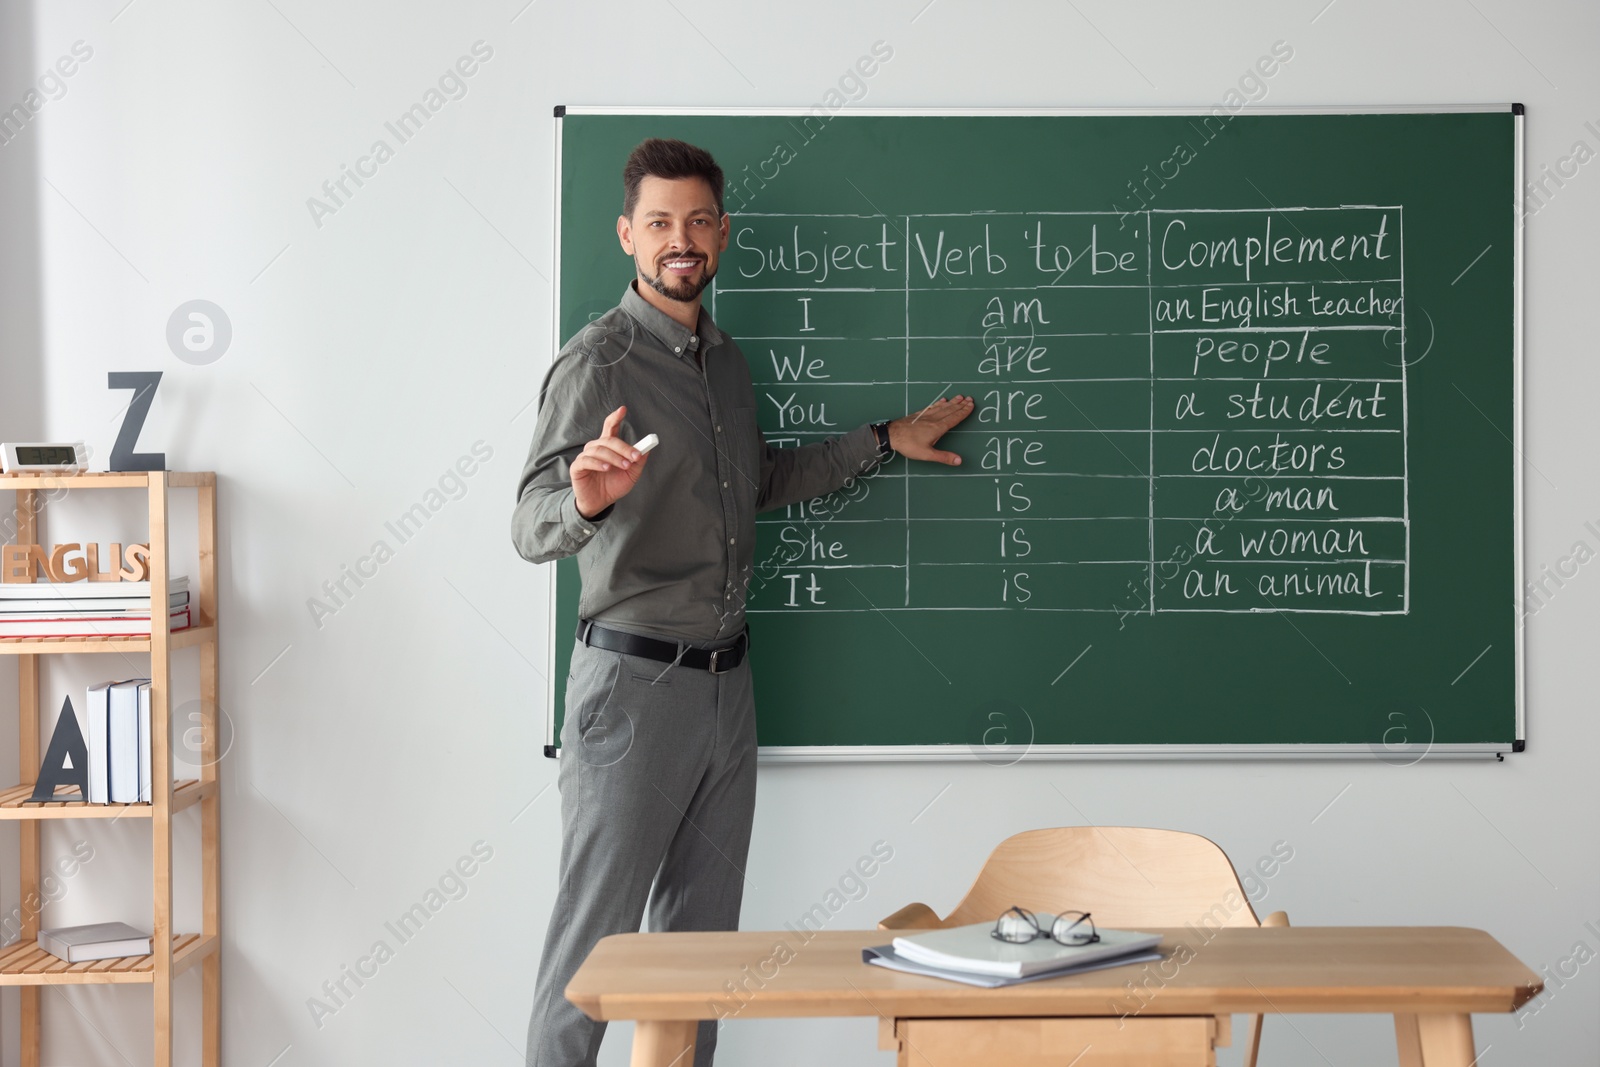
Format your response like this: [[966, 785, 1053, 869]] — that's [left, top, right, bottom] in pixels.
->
[[528, 643, 755, 1067]]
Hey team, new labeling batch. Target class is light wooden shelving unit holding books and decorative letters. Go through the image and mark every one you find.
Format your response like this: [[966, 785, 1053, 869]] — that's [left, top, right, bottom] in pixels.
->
[[0, 470, 222, 1067]]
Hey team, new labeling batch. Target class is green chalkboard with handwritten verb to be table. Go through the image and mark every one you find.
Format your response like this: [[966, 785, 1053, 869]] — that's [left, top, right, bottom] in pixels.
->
[[549, 106, 1523, 761]]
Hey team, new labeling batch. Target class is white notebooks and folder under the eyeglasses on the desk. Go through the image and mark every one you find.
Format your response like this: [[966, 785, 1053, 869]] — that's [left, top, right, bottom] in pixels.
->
[[861, 915, 1162, 989]]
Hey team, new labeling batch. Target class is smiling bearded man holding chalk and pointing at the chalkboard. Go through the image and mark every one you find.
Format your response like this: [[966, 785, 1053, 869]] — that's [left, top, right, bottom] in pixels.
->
[[512, 139, 973, 1067]]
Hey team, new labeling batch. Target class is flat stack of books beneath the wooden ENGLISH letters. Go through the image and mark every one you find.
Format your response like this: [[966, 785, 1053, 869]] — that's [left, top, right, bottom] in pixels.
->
[[0, 577, 189, 637]]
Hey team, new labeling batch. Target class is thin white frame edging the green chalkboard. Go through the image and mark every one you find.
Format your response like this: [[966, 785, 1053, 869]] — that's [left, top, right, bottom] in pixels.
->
[[544, 104, 1528, 765]]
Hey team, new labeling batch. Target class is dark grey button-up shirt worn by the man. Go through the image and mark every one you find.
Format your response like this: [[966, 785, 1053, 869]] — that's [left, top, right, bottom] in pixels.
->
[[512, 283, 878, 645]]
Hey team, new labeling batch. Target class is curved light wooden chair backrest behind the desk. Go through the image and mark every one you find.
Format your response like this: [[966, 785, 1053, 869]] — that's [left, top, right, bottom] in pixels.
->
[[941, 825, 1261, 929]]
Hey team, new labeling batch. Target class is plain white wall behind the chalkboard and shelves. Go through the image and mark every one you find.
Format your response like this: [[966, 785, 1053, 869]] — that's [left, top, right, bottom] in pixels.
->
[[0, 0, 1600, 1067]]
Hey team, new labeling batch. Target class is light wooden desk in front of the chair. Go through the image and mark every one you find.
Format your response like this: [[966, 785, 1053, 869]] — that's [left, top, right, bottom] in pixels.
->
[[566, 926, 1544, 1067]]
